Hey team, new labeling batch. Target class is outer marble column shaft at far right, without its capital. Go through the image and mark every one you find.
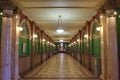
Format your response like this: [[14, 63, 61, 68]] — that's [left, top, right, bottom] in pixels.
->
[[107, 12, 119, 80]]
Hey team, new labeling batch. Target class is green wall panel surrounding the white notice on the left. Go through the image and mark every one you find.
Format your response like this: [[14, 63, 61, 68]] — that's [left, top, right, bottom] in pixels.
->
[[19, 37, 31, 57]]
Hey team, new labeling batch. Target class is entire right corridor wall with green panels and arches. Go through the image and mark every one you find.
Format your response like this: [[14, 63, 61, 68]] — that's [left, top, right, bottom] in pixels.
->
[[69, 14, 101, 76]]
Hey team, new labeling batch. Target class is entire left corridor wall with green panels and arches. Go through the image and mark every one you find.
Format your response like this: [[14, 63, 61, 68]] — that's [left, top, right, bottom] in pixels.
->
[[19, 13, 55, 76]]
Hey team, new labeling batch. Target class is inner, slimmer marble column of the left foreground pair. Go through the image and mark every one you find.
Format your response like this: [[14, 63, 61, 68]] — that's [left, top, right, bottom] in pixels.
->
[[11, 15, 20, 80]]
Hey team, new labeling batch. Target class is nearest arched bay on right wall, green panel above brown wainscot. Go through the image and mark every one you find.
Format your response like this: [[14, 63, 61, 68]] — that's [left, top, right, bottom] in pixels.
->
[[90, 19, 101, 77]]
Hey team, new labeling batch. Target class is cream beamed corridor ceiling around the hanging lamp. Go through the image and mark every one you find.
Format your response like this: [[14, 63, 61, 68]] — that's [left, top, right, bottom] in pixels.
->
[[13, 0, 105, 41]]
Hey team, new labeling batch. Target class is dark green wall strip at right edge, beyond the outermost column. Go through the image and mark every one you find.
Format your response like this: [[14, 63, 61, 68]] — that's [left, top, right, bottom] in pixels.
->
[[116, 9, 120, 58]]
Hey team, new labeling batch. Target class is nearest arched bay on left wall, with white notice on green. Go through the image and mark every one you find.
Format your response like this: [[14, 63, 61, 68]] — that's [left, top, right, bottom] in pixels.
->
[[18, 19, 32, 76]]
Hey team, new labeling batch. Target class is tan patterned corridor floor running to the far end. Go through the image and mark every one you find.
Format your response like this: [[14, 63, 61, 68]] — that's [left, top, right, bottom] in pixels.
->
[[21, 53, 100, 80]]
